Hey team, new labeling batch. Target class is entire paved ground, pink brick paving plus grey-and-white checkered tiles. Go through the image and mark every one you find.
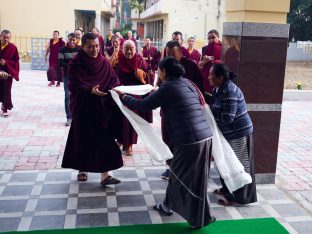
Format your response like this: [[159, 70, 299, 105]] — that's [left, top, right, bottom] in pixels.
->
[[0, 71, 312, 233]]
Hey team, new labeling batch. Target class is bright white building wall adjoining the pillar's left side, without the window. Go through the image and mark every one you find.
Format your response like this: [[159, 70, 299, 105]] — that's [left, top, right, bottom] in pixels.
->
[[143, 0, 224, 41]]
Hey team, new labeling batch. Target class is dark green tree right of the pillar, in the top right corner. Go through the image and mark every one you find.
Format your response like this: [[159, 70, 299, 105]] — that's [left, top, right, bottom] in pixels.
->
[[287, 0, 312, 41]]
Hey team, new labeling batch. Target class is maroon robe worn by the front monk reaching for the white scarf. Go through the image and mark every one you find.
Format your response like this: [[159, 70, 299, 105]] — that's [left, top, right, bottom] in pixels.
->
[[62, 50, 123, 172]]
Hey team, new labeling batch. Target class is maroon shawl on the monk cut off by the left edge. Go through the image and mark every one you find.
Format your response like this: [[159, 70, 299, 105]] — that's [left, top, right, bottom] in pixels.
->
[[0, 42, 19, 81]]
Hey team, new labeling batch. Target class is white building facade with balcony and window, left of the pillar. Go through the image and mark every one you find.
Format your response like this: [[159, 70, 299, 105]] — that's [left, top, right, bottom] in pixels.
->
[[140, 0, 224, 41]]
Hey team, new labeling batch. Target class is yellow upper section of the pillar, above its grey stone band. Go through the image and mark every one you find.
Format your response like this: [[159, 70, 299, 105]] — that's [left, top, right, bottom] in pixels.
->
[[225, 0, 290, 23]]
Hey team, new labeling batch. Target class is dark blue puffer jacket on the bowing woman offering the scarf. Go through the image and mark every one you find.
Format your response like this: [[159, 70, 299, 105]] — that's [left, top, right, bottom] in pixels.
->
[[122, 78, 212, 145]]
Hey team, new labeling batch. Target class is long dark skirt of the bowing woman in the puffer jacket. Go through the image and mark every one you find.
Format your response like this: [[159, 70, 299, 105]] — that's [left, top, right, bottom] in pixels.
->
[[164, 139, 214, 227]]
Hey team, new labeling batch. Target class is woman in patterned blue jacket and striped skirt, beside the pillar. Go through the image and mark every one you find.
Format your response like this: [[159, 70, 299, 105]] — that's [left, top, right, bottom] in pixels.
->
[[209, 64, 257, 205]]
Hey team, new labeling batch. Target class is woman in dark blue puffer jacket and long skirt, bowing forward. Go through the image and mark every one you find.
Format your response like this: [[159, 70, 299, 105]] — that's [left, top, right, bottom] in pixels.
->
[[119, 57, 215, 228]]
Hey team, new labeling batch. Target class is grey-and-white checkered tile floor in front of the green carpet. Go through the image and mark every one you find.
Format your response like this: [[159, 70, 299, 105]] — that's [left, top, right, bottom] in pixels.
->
[[0, 166, 312, 233]]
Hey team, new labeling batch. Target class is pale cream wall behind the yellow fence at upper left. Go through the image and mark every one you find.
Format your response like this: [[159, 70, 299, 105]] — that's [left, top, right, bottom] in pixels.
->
[[0, 0, 111, 37]]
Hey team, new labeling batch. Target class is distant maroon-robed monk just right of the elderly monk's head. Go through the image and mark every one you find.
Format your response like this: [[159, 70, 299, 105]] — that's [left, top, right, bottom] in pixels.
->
[[141, 37, 160, 84]]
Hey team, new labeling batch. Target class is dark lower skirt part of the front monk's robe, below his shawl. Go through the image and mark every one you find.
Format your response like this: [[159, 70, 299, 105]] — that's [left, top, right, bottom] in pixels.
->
[[62, 116, 123, 172]]
